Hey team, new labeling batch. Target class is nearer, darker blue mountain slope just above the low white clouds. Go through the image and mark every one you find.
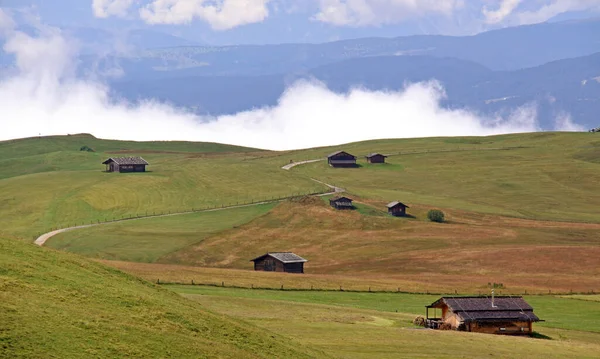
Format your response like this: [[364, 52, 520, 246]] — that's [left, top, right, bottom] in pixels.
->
[[112, 53, 600, 129]]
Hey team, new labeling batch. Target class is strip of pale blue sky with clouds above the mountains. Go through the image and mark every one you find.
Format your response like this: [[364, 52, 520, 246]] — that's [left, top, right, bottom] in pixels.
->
[[0, 0, 600, 44]]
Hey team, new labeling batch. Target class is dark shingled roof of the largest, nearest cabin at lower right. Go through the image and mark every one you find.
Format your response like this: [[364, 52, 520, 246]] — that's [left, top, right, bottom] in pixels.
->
[[427, 296, 540, 322]]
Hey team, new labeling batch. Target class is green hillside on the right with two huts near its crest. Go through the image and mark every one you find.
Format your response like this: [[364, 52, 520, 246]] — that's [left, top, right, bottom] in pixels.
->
[[280, 133, 600, 222]]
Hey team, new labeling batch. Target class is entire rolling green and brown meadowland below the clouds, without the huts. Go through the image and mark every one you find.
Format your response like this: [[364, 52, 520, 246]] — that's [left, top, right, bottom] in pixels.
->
[[0, 133, 600, 358]]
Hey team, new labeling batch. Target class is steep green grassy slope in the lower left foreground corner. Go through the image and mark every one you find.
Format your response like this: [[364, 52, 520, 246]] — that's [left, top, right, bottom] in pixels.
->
[[0, 239, 324, 358]]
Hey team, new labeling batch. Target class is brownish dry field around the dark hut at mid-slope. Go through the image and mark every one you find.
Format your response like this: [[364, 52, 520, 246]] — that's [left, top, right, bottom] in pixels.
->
[[102, 198, 600, 293]]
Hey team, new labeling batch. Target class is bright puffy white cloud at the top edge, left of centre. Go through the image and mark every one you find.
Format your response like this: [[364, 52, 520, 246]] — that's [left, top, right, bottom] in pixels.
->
[[140, 0, 271, 30]]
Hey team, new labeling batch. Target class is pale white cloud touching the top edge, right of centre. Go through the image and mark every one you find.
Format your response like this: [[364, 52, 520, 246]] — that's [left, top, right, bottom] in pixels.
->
[[314, 0, 465, 26]]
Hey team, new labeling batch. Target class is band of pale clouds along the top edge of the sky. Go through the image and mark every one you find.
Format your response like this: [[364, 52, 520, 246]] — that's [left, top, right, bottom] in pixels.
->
[[92, 0, 600, 31]]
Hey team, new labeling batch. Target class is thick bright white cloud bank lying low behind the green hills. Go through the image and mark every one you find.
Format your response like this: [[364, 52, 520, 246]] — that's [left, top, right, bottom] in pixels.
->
[[0, 14, 572, 150]]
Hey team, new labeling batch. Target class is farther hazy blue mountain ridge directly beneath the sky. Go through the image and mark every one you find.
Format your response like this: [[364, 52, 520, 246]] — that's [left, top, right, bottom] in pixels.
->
[[84, 19, 600, 80]]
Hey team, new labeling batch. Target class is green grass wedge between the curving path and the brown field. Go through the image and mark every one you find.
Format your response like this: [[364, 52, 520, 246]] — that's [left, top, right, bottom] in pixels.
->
[[46, 204, 275, 262]]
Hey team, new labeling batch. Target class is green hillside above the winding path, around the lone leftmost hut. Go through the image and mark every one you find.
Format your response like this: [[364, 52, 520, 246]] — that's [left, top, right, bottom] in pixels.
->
[[0, 136, 326, 238]]
